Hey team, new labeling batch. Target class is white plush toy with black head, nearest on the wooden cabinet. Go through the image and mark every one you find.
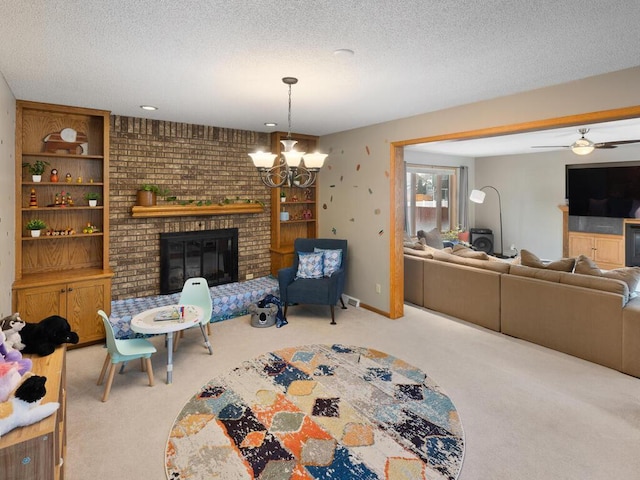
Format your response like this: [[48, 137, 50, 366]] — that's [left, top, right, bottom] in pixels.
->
[[0, 373, 60, 437]]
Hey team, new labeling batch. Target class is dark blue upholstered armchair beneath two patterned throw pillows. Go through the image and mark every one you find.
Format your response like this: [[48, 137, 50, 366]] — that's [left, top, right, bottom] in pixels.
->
[[278, 238, 347, 325]]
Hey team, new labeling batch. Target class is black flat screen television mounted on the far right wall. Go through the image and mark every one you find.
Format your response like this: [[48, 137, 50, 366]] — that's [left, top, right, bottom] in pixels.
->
[[566, 161, 640, 218]]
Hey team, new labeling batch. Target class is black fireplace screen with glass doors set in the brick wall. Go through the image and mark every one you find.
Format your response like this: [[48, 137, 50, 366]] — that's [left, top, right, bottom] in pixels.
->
[[160, 228, 238, 294]]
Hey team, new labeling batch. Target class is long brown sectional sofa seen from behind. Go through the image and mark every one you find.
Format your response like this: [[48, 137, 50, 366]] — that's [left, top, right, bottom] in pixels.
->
[[404, 247, 640, 377]]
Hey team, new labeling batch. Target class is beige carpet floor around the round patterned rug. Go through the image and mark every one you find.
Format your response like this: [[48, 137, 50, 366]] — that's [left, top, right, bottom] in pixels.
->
[[65, 306, 640, 480]]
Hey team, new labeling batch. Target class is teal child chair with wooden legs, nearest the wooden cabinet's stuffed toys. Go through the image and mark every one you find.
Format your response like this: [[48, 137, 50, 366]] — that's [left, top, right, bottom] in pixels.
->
[[98, 310, 156, 402]]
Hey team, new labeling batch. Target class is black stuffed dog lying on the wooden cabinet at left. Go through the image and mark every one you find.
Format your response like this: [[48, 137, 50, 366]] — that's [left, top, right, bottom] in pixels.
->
[[20, 315, 79, 357]]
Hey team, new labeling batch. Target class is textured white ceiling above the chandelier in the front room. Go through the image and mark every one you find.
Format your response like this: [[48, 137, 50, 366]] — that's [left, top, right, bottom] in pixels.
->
[[0, 0, 640, 135]]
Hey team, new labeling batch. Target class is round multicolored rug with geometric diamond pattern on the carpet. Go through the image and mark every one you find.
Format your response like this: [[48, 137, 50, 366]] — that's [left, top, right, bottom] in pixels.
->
[[166, 345, 464, 480]]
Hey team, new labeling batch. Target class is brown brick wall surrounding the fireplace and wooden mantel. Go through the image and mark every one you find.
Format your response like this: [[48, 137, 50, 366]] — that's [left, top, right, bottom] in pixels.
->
[[109, 115, 271, 300]]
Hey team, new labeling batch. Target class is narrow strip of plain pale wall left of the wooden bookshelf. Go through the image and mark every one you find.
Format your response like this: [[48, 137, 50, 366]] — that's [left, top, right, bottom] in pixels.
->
[[0, 73, 16, 318]]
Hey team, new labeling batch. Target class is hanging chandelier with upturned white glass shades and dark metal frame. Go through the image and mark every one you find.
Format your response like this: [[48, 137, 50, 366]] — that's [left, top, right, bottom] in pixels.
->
[[249, 77, 327, 188]]
